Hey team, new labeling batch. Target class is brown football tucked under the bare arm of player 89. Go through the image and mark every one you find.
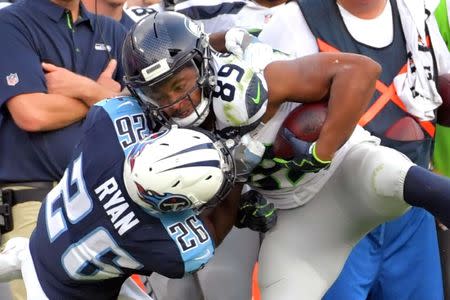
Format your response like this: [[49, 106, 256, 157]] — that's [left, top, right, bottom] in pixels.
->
[[273, 101, 328, 159]]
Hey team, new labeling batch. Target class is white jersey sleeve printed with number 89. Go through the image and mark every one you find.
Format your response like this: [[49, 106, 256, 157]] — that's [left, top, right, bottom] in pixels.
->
[[212, 47, 290, 137]]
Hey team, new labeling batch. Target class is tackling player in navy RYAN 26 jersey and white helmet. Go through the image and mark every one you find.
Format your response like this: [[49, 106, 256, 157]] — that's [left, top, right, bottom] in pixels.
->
[[0, 97, 246, 299]]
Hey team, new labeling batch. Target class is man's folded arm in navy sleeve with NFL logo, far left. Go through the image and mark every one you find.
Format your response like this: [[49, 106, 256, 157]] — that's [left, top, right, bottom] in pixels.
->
[[0, 19, 116, 131]]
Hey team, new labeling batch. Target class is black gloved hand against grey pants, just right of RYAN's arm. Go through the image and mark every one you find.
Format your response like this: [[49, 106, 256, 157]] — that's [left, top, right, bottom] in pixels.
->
[[234, 190, 277, 233]]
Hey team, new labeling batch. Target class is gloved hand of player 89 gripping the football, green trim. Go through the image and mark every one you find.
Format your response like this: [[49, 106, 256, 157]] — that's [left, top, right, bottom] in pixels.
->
[[273, 128, 331, 173]]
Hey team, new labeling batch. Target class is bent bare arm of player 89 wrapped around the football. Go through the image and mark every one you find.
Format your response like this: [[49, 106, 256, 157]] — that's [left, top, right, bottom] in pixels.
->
[[264, 53, 381, 160]]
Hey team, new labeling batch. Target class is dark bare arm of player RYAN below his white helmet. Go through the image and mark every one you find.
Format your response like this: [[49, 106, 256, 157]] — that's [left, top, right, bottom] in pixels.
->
[[200, 183, 242, 247]]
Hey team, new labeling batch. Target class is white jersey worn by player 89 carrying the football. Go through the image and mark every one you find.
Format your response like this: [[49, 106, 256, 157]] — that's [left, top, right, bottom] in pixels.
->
[[212, 42, 379, 209]]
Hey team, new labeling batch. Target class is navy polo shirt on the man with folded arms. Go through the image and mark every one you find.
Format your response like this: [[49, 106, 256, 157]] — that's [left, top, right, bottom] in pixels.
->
[[0, 0, 126, 182]]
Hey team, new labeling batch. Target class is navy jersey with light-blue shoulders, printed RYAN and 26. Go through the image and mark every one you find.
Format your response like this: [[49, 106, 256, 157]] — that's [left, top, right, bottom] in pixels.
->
[[30, 97, 214, 300]]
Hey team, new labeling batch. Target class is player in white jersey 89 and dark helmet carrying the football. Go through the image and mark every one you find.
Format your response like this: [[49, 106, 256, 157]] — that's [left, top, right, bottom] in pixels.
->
[[123, 13, 450, 300]]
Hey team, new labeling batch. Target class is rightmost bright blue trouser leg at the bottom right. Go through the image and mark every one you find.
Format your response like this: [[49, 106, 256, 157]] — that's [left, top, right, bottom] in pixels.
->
[[369, 208, 444, 300]]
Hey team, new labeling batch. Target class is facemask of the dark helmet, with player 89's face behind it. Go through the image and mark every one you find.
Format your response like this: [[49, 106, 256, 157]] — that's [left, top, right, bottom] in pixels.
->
[[125, 35, 215, 127]]
